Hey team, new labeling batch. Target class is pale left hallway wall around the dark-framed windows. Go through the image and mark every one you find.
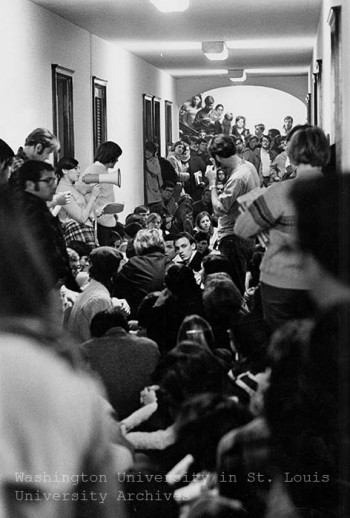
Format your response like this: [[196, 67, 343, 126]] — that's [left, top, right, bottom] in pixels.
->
[[0, 0, 178, 216]]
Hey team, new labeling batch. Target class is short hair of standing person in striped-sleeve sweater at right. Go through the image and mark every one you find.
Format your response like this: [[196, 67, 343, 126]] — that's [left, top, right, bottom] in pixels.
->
[[288, 124, 330, 167]]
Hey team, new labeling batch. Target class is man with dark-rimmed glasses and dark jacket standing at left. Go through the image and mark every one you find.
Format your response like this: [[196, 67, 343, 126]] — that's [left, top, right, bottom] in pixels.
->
[[18, 160, 79, 291]]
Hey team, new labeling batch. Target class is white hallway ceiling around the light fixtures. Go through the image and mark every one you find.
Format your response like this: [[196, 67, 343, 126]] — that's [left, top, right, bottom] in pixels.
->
[[32, 0, 322, 78]]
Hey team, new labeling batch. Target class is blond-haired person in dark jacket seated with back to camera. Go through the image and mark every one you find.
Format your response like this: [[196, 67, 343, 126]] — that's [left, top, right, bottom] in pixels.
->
[[113, 228, 168, 319]]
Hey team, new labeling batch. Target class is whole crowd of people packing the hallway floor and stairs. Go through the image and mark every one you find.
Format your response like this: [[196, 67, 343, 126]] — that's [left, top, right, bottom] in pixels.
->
[[0, 118, 350, 518]]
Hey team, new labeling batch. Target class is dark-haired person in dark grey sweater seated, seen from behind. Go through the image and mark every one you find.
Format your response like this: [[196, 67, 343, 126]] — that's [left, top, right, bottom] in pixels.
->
[[80, 308, 159, 420]]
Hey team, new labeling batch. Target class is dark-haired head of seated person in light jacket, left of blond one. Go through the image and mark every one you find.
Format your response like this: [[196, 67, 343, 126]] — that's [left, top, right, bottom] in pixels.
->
[[89, 246, 123, 285]]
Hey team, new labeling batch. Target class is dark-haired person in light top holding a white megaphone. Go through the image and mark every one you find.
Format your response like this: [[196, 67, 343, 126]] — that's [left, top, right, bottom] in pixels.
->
[[76, 141, 123, 246]]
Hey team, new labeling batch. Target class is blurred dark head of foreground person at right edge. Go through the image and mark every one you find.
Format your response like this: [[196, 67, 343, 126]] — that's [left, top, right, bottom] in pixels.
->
[[291, 173, 350, 284]]
